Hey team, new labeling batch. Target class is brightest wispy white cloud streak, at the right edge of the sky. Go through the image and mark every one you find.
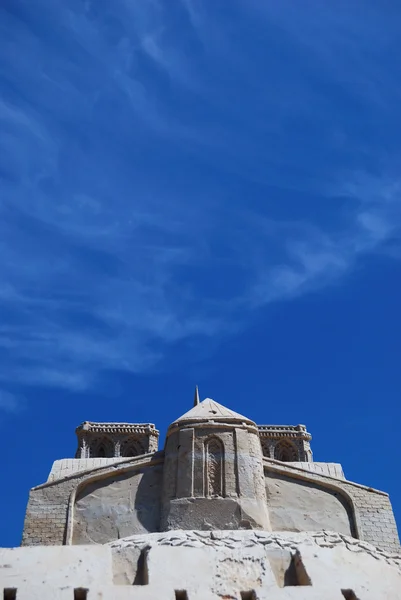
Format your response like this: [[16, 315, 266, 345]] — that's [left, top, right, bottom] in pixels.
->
[[250, 181, 401, 305]]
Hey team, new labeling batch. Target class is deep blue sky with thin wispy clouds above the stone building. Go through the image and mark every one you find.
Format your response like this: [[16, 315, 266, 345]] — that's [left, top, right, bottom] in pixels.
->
[[0, 0, 401, 546]]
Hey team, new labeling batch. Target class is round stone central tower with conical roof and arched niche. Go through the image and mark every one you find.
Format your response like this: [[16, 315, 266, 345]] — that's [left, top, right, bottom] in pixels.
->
[[161, 397, 271, 531]]
